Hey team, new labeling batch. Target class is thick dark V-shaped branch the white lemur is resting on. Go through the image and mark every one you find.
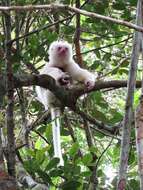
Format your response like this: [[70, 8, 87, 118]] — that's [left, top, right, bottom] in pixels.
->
[[0, 74, 141, 107]]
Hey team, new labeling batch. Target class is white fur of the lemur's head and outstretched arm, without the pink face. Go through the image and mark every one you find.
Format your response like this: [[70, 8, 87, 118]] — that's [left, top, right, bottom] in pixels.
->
[[47, 41, 95, 89]]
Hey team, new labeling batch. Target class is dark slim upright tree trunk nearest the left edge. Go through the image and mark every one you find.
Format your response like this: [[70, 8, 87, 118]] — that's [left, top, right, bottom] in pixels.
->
[[4, 0, 15, 178]]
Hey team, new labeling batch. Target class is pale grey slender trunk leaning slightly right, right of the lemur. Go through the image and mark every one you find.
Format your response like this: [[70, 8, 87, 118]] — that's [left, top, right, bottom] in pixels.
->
[[117, 0, 142, 190]]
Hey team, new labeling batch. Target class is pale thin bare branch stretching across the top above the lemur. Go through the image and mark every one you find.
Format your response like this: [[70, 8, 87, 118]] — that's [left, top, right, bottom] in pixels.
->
[[0, 4, 143, 32]]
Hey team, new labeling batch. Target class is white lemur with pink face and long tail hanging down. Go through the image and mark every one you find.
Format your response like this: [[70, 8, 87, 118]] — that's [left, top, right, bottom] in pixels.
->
[[36, 41, 95, 165]]
